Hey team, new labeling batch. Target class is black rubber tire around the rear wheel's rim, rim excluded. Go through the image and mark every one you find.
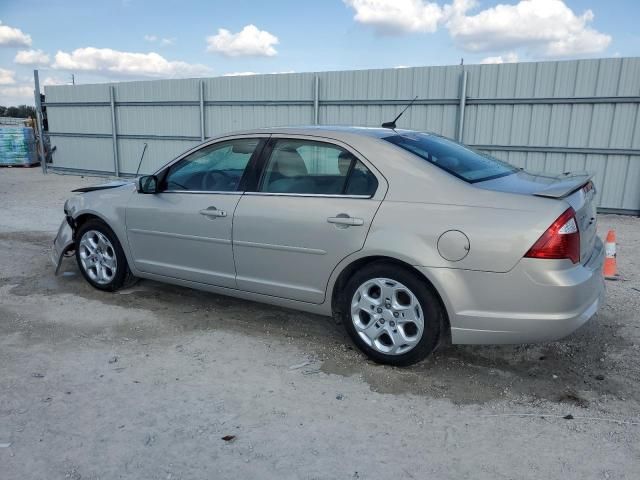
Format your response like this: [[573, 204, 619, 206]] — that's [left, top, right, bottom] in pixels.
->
[[340, 262, 445, 367]]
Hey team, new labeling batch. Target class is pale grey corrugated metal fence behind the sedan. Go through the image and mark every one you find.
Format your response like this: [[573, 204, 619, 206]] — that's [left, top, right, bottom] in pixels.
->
[[45, 58, 640, 214]]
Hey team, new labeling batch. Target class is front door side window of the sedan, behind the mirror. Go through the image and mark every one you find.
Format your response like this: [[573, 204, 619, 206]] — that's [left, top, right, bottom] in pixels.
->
[[163, 138, 260, 192]]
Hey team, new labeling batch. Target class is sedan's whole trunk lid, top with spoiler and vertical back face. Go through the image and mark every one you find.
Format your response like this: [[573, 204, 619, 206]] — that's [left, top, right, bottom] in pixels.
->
[[474, 170, 597, 264]]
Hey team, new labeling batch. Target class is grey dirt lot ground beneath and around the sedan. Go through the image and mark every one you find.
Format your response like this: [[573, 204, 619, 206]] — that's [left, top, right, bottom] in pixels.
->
[[0, 169, 640, 480]]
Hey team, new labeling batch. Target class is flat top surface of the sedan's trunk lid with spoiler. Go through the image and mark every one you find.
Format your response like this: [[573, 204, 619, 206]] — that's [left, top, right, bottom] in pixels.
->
[[475, 170, 593, 198]]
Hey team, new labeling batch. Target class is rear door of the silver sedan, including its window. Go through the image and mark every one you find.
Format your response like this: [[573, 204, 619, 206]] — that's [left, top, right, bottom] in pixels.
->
[[233, 136, 386, 303]]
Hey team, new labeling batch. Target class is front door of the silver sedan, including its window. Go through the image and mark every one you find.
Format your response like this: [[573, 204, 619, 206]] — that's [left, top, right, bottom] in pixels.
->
[[126, 138, 262, 288]]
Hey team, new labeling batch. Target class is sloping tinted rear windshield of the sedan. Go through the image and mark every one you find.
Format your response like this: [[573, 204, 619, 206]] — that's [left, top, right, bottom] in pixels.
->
[[384, 133, 517, 183]]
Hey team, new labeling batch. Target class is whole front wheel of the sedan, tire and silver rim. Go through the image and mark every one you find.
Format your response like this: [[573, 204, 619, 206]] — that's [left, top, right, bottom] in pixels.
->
[[75, 219, 136, 292]]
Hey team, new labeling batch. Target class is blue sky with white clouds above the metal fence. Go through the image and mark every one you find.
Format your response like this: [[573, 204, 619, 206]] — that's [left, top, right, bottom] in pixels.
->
[[0, 0, 640, 104]]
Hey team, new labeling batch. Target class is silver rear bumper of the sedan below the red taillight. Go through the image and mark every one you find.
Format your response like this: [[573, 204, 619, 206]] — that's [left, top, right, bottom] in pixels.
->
[[423, 239, 605, 344]]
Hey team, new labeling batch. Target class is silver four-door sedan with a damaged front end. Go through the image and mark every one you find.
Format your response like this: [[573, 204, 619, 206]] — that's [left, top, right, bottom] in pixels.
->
[[51, 127, 604, 365]]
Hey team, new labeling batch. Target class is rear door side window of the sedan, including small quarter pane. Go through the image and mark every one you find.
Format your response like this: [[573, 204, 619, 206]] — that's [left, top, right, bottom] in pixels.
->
[[260, 139, 378, 196]]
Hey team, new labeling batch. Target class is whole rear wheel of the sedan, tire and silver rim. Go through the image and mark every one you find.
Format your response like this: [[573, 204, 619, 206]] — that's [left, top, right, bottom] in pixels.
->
[[340, 262, 445, 366]]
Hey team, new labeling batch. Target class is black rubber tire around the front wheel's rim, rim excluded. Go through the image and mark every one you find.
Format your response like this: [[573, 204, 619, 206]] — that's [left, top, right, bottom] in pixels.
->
[[75, 218, 137, 292]]
